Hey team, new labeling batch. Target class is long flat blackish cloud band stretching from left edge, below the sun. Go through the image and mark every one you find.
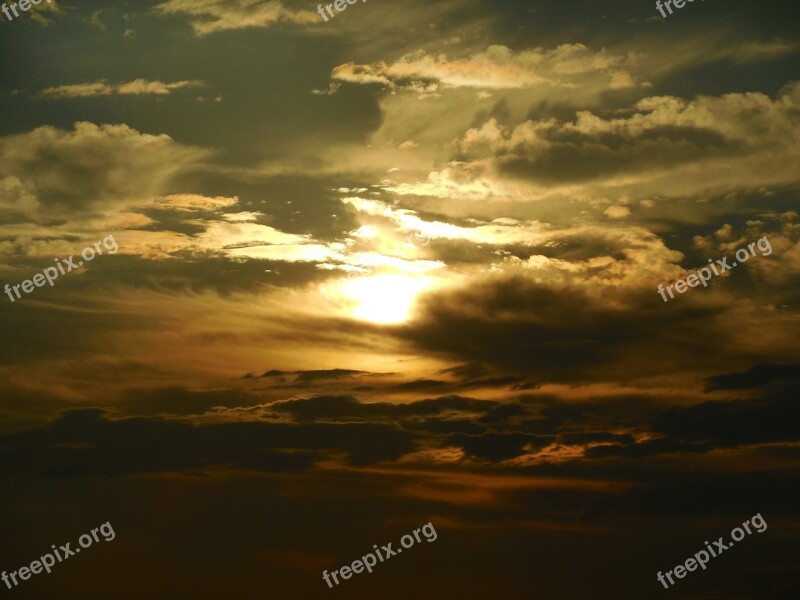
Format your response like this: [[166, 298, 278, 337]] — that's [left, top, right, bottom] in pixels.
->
[[0, 409, 414, 477]]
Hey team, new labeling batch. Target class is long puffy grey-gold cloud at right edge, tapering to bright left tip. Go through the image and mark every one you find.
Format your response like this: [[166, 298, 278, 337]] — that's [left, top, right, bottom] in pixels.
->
[[384, 82, 800, 206]]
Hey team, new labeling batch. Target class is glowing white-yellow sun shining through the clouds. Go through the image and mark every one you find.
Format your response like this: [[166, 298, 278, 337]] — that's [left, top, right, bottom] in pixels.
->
[[335, 273, 430, 324]]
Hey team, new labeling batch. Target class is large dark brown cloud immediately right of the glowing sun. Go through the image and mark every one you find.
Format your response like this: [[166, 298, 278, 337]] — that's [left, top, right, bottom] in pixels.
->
[[400, 276, 726, 381]]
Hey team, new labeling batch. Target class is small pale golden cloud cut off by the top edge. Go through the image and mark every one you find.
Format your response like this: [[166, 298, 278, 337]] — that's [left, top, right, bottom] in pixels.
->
[[154, 0, 322, 36]]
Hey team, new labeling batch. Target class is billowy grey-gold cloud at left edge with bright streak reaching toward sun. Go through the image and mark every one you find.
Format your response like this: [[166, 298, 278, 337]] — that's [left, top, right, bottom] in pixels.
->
[[0, 122, 356, 264]]
